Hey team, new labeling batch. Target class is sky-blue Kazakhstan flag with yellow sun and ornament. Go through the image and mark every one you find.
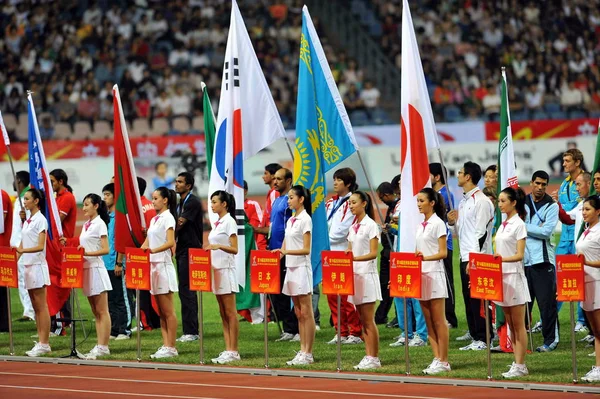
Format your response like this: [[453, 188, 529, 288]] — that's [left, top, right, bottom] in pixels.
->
[[294, 6, 358, 285]]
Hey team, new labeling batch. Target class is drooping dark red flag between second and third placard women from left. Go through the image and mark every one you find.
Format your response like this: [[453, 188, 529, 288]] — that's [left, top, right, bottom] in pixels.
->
[[113, 85, 146, 253]]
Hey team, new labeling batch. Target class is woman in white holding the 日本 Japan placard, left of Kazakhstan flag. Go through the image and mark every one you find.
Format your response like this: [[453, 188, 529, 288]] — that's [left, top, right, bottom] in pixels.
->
[[273, 186, 316, 366]]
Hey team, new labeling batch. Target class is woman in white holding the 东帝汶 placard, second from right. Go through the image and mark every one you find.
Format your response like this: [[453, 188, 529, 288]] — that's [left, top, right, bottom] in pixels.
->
[[495, 187, 531, 378]]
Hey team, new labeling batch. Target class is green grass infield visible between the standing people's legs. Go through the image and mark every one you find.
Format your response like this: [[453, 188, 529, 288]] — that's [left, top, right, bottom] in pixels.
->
[[0, 247, 594, 383]]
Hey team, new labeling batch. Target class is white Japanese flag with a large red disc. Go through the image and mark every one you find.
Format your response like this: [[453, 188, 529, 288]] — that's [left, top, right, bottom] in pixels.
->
[[399, 0, 440, 252]]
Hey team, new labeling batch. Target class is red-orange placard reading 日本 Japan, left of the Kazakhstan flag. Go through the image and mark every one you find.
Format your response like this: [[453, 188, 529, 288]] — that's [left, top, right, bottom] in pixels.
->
[[250, 250, 281, 294]]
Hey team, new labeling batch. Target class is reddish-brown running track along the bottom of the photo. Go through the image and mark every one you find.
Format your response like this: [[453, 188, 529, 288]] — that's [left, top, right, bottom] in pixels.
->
[[0, 361, 584, 399]]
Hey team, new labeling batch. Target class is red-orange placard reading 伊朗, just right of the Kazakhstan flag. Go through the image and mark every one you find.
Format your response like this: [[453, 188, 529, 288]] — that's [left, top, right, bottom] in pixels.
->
[[321, 251, 354, 295]]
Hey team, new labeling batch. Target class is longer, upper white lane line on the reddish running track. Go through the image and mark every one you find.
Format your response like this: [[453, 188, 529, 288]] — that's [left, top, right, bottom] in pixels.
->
[[0, 371, 449, 399]]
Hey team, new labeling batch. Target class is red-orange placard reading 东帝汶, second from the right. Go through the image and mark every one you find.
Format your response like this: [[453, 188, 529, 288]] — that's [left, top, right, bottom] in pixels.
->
[[469, 253, 504, 302]]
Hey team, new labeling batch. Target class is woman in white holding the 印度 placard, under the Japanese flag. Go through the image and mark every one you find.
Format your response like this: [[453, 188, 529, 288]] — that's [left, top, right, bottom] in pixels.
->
[[416, 188, 450, 375]]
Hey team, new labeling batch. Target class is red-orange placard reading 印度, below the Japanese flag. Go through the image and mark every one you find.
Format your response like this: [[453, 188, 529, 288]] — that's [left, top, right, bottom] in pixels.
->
[[390, 252, 423, 299]]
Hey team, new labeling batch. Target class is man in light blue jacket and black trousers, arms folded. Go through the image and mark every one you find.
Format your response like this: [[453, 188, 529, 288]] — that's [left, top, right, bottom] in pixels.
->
[[524, 170, 559, 352]]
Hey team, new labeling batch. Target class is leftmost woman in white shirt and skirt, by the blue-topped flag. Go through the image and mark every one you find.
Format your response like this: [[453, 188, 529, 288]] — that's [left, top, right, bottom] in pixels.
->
[[17, 188, 51, 357]]
